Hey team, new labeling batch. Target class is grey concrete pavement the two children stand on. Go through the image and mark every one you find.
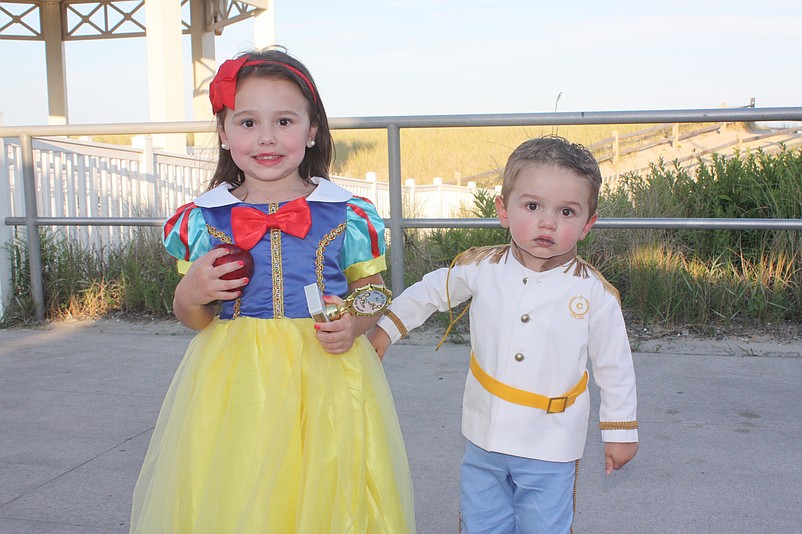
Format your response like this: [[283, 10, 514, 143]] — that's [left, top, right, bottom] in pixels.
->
[[0, 320, 802, 534]]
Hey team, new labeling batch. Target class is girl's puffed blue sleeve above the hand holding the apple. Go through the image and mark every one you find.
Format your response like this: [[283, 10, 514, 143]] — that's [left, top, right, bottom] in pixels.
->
[[162, 202, 211, 274]]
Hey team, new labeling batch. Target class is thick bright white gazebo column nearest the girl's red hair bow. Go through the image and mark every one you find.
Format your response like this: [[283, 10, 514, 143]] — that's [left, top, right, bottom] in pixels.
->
[[145, 0, 186, 153]]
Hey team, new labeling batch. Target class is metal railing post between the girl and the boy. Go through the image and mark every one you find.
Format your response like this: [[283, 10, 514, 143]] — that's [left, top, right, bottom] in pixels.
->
[[387, 124, 404, 295]]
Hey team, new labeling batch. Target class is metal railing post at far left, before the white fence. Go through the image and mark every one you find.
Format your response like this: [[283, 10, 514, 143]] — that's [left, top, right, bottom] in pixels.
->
[[19, 134, 45, 323]]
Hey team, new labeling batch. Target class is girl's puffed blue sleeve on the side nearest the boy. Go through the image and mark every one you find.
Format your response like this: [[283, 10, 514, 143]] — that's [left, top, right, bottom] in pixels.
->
[[340, 197, 387, 284]]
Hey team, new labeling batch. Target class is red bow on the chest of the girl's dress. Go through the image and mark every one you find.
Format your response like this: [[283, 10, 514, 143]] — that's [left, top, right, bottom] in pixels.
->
[[231, 197, 312, 250]]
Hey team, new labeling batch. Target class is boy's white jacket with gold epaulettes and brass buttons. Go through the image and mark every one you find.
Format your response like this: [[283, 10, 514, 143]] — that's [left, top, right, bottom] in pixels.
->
[[379, 247, 638, 462]]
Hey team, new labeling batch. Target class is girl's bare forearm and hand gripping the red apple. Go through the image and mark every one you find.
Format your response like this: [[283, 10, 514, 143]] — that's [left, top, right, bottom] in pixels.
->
[[173, 249, 248, 330]]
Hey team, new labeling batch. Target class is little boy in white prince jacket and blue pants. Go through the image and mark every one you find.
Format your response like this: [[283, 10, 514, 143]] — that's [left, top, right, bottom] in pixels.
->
[[369, 137, 638, 534]]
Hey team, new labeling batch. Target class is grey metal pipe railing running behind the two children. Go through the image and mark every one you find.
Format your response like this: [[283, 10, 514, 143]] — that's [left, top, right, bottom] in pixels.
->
[[0, 107, 802, 322]]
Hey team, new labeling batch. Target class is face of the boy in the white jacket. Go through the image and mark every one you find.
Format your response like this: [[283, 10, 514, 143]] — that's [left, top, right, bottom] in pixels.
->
[[496, 165, 596, 271]]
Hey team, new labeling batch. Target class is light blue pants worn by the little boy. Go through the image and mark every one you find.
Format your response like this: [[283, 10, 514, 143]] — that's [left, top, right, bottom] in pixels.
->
[[461, 441, 576, 534]]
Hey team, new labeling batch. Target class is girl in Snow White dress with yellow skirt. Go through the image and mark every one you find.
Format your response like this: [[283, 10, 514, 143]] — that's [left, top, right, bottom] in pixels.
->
[[131, 49, 415, 534]]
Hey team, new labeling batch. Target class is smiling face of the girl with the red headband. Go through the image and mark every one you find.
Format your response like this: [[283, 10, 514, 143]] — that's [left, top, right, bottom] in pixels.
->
[[219, 76, 317, 195]]
